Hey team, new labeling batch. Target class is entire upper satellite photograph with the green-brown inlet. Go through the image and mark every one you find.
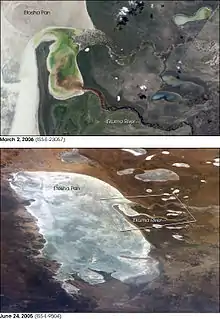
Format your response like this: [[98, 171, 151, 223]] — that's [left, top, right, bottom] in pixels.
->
[[1, 0, 219, 136]]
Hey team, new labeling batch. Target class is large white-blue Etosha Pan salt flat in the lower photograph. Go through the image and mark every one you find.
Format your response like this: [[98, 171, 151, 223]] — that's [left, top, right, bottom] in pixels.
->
[[10, 172, 158, 284]]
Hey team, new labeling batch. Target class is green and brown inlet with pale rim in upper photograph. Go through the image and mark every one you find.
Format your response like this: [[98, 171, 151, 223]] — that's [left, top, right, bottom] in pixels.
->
[[34, 28, 83, 100]]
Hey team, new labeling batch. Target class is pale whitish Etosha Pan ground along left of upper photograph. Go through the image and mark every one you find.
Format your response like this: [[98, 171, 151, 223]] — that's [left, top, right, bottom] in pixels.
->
[[2, 0, 95, 135]]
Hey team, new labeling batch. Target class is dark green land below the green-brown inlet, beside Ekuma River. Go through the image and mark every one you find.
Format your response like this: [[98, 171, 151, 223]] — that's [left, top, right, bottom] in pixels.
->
[[47, 92, 144, 135]]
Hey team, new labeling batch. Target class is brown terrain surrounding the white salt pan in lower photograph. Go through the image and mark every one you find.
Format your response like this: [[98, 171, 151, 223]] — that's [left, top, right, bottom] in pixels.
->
[[1, 149, 219, 312]]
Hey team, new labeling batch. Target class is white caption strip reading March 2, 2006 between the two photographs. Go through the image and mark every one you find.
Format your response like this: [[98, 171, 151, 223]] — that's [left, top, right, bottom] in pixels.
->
[[0, 136, 220, 149]]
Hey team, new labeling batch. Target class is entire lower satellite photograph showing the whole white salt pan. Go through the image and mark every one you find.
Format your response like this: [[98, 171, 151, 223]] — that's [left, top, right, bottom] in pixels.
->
[[1, 148, 219, 313]]
